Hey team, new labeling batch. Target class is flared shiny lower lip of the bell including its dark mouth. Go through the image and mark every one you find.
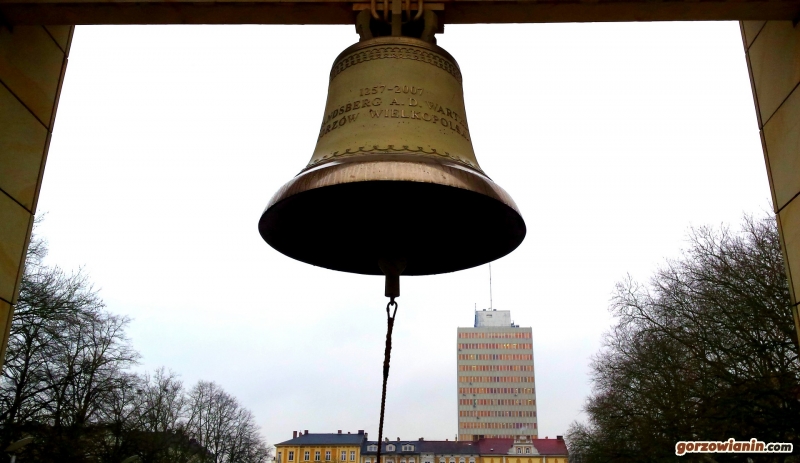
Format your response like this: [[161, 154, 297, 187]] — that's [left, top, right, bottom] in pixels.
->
[[258, 158, 526, 275]]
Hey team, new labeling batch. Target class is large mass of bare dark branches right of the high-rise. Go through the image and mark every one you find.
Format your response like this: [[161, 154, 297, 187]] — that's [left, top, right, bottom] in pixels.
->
[[568, 218, 800, 463]]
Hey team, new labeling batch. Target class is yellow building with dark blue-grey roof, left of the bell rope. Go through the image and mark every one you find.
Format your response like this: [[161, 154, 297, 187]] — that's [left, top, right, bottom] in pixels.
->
[[275, 430, 367, 463]]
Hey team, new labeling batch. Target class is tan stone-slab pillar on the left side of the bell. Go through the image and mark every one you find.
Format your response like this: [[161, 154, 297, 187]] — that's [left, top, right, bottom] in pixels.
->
[[0, 22, 74, 362]]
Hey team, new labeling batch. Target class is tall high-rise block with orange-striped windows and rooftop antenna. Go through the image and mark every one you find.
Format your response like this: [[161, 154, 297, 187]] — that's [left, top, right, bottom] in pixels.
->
[[457, 310, 538, 440]]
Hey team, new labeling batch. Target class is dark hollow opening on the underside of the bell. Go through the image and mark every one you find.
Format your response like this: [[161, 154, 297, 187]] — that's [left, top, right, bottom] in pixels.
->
[[258, 173, 527, 276]]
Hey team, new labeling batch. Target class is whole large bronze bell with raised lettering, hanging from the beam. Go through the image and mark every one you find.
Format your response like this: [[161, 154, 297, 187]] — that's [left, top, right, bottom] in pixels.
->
[[258, 16, 525, 280]]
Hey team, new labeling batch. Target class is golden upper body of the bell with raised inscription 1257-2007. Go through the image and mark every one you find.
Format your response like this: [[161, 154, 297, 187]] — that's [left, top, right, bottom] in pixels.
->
[[307, 37, 482, 172]]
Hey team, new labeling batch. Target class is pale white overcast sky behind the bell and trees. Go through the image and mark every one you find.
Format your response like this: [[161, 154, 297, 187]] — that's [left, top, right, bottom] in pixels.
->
[[34, 22, 770, 444]]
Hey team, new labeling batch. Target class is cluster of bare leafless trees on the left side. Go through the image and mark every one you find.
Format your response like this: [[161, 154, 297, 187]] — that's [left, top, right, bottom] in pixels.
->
[[0, 228, 268, 463]]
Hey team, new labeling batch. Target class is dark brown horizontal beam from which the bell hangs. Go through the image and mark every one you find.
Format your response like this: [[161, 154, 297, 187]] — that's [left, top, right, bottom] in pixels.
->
[[0, 0, 800, 26]]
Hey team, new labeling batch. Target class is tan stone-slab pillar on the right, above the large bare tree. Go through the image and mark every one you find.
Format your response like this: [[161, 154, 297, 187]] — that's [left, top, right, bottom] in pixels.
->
[[740, 21, 800, 348]]
